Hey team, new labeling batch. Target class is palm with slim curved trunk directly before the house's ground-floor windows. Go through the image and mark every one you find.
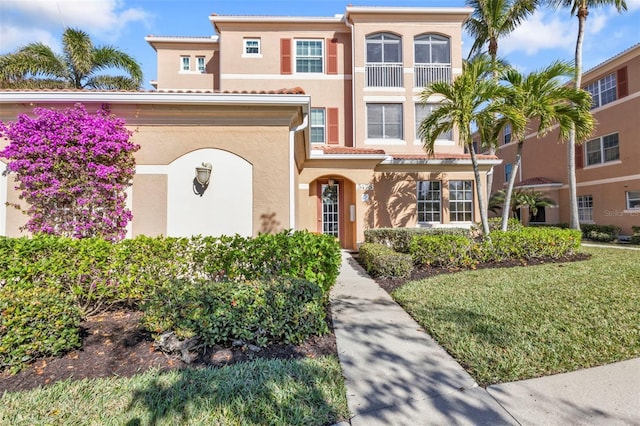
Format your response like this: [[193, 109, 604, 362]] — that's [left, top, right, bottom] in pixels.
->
[[418, 55, 524, 236]]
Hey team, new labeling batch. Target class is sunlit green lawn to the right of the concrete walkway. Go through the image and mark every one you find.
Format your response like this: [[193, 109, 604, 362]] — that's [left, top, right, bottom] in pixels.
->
[[393, 247, 640, 386]]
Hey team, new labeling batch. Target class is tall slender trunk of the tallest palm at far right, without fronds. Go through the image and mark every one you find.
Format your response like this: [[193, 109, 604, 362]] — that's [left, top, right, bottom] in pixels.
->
[[567, 10, 589, 230]]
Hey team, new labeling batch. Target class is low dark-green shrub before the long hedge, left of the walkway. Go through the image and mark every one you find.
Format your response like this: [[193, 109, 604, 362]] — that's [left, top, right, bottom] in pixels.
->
[[142, 277, 329, 346]]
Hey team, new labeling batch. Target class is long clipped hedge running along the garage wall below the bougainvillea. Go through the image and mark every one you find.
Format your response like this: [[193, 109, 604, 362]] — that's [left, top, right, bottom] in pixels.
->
[[0, 231, 341, 315]]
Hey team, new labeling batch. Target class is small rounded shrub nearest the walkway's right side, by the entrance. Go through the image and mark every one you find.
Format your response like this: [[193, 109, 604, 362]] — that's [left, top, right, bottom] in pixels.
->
[[359, 243, 413, 278]]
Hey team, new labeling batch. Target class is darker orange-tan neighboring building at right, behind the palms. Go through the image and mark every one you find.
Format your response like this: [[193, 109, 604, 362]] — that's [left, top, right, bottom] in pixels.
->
[[493, 44, 640, 235]]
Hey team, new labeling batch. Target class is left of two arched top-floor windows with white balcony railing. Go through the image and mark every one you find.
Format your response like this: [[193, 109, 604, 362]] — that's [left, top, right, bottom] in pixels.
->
[[365, 33, 403, 87]]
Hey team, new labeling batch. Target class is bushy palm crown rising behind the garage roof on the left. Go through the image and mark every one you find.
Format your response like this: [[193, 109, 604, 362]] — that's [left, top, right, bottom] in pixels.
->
[[0, 28, 142, 90]]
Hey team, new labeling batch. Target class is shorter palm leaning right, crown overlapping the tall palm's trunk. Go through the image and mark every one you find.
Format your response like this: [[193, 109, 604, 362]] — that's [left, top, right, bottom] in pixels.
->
[[496, 61, 594, 231]]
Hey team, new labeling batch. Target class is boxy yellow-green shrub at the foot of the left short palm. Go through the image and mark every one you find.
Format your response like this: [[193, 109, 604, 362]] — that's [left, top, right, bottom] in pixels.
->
[[411, 234, 478, 268]]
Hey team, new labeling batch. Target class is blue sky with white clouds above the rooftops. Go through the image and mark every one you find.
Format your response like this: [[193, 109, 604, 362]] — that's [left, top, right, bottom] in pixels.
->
[[0, 0, 640, 89]]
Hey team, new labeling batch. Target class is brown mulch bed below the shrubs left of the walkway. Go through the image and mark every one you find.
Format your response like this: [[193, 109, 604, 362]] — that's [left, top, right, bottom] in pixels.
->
[[0, 311, 338, 396]]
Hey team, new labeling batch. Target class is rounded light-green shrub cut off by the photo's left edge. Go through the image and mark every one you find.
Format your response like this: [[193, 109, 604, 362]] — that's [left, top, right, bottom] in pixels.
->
[[0, 282, 81, 373]]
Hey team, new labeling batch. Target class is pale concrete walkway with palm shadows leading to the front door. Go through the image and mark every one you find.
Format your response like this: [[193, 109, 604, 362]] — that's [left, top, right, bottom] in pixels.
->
[[331, 252, 640, 426]]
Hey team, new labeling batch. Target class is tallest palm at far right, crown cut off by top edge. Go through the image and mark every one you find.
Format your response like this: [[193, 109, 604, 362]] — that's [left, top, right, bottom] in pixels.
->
[[546, 0, 627, 229]]
